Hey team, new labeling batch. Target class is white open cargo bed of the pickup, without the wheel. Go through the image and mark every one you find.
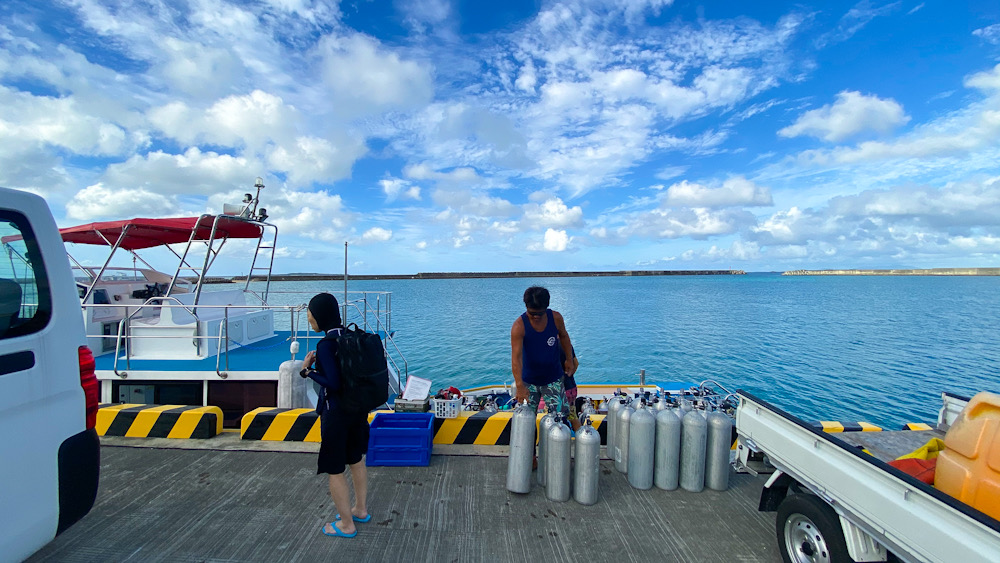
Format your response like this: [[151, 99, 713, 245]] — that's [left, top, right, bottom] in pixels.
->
[[736, 391, 1000, 563]]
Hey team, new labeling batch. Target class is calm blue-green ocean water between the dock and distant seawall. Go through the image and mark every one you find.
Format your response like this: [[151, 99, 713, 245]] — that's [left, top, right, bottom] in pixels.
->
[[246, 274, 1000, 428]]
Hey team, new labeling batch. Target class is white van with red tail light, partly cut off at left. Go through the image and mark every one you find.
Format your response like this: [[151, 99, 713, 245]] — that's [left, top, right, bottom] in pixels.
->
[[0, 188, 100, 561]]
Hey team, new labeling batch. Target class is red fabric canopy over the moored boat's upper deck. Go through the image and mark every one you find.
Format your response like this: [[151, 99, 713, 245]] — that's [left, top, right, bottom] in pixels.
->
[[59, 215, 261, 250]]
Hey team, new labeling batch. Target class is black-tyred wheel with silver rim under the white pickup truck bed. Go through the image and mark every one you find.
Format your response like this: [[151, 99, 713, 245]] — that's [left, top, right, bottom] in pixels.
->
[[774, 494, 853, 563]]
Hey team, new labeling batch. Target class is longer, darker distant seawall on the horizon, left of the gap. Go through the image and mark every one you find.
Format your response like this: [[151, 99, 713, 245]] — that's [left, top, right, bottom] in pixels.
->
[[228, 270, 746, 282]]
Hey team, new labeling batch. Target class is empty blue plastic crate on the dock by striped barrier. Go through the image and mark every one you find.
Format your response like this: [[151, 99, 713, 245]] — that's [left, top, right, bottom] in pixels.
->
[[366, 412, 434, 466]]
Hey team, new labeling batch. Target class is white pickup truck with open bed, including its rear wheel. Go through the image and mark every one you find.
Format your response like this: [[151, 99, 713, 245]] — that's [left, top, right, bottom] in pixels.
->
[[736, 391, 1000, 563]]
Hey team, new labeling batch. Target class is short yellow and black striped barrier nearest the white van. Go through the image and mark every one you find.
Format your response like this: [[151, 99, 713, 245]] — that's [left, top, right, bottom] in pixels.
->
[[97, 403, 222, 439]]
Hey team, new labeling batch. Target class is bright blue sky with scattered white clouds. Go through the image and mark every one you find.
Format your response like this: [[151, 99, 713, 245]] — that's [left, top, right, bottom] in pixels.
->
[[0, 0, 1000, 274]]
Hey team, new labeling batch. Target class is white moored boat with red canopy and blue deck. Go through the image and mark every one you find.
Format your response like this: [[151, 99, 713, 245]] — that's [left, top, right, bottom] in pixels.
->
[[3, 178, 407, 426]]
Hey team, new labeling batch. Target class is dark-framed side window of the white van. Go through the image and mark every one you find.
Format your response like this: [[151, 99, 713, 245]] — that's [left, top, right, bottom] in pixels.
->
[[0, 209, 52, 340]]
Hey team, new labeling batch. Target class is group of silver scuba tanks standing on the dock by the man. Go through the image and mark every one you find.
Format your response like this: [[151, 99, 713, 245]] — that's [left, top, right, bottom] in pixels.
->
[[507, 391, 733, 505]]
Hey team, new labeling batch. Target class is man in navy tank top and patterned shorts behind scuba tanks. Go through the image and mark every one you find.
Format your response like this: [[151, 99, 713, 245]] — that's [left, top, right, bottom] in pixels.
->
[[510, 286, 576, 416]]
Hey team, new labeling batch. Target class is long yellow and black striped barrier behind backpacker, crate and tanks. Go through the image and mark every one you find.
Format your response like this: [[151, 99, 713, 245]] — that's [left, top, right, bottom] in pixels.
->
[[240, 407, 607, 446]]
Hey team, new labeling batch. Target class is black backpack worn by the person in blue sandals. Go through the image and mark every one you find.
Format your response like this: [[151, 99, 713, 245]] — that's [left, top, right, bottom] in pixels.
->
[[327, 323, 389, 412]]
